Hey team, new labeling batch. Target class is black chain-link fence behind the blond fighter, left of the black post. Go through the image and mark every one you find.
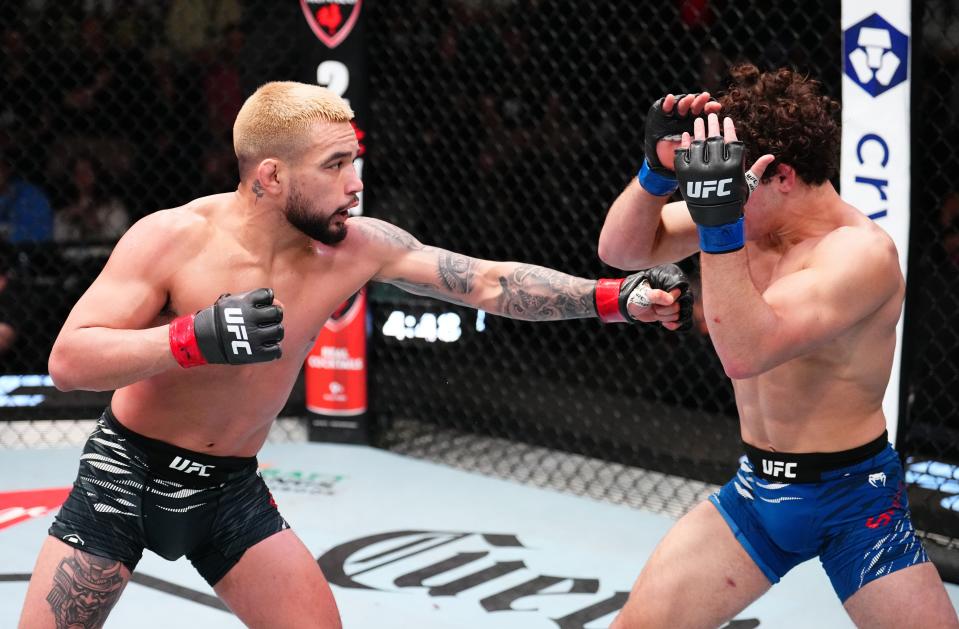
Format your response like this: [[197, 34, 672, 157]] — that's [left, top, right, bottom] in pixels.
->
[[0, 0, 309, 434]]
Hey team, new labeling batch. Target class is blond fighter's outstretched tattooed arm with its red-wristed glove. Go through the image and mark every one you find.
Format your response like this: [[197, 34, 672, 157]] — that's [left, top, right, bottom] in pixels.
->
[[351, 218, 690, 330]]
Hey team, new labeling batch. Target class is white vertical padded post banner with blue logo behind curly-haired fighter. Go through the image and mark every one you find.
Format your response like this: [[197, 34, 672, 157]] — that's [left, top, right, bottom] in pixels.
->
[[839, 0, 912, 443]]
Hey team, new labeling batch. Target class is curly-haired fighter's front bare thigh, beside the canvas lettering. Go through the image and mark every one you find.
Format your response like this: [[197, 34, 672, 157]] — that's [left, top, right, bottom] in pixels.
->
[[610, 502, 770, 629]]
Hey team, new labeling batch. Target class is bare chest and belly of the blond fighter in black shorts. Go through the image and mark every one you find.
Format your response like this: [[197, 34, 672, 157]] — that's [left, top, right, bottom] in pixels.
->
[[112, 194, 377, 456]]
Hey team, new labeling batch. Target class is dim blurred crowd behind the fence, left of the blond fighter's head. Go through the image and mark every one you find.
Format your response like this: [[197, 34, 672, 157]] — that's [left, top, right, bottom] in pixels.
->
[[0, 0, 268, 250]]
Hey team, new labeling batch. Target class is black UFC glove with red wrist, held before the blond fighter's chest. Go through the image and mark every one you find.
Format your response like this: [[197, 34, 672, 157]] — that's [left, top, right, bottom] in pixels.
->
[[170, 288, 283, 368]]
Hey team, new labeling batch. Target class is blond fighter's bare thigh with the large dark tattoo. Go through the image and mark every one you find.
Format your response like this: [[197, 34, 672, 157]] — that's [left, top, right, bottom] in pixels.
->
[[19, 537, 130, 629]]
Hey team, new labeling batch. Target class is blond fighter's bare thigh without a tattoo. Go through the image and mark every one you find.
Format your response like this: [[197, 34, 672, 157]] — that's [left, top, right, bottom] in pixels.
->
[[213, 529, 342, 629]]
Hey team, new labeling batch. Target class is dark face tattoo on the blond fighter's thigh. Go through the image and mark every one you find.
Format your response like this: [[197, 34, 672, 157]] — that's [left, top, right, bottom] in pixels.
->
[[47, 550, 126, 629]]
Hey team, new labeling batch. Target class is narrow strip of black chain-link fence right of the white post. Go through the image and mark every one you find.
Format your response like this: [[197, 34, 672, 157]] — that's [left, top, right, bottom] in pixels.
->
[[899, 0, 959, 568]]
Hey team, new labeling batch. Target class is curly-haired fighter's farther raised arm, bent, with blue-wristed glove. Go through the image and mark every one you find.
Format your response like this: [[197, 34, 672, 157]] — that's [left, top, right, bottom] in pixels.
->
[[599, 92, 719, 269]]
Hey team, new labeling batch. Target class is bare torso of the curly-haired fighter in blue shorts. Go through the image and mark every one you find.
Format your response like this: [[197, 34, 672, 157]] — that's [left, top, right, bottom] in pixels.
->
[[733, 213, 905, 452]]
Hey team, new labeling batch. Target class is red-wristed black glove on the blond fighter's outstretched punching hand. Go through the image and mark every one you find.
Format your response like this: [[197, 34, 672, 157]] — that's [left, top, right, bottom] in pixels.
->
[[593, 264, 693, 332]]
